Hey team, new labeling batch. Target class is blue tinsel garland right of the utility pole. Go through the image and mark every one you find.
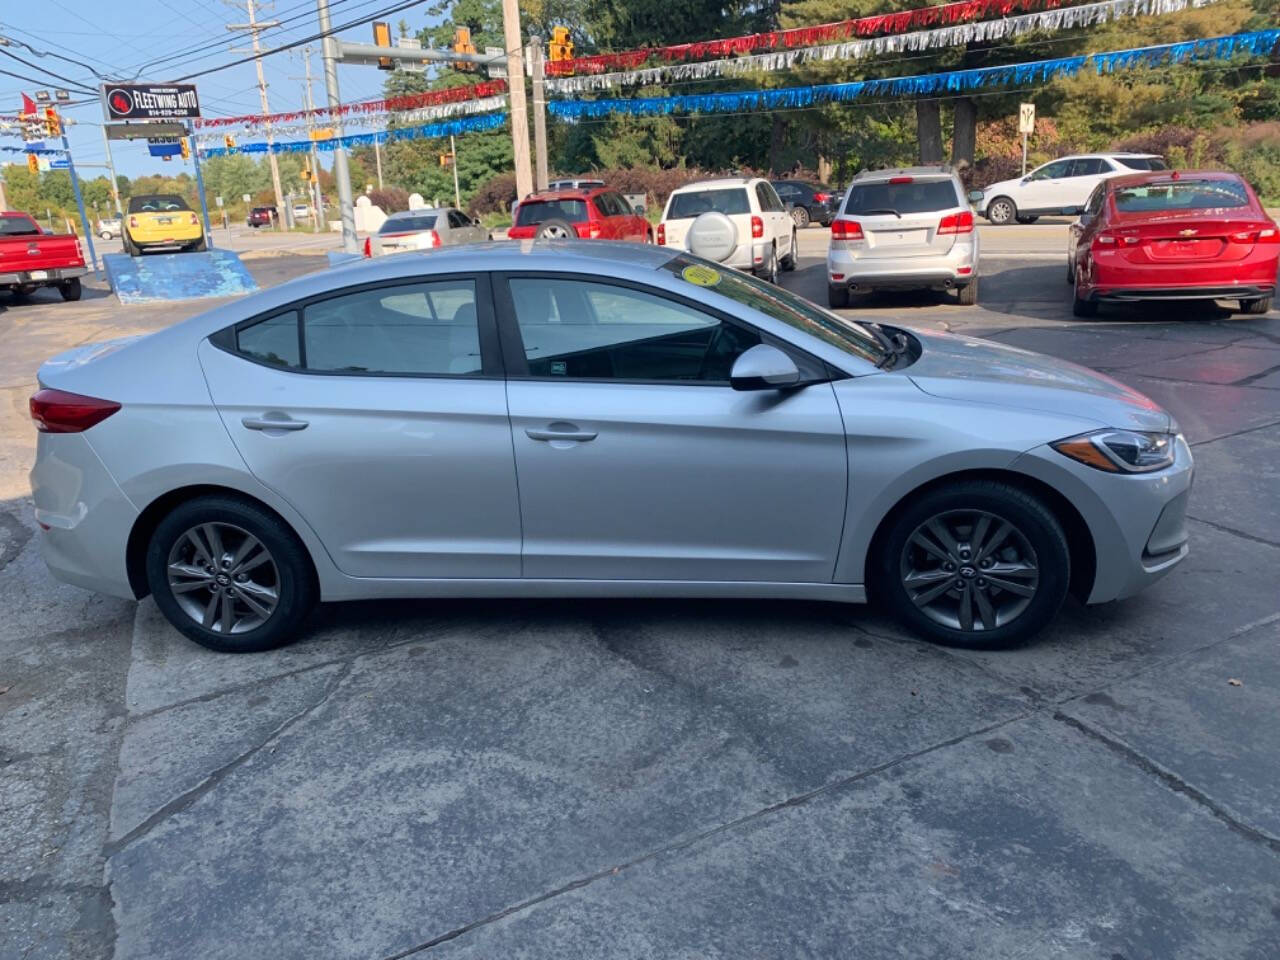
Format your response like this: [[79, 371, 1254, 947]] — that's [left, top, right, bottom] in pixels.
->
[[547, 29, 1280, 118]]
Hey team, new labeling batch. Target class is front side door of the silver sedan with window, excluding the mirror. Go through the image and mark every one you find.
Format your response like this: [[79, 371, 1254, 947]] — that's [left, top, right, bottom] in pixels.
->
[[495, 274, 847, 582]]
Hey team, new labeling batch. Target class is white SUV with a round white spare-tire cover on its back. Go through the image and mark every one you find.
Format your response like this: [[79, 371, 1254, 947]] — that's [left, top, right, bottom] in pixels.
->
[[658, 177, 796, 283]]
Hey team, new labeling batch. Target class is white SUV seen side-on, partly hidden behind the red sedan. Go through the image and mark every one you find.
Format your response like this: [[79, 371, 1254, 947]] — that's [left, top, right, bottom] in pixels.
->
[[977, 154, 1167, 224]]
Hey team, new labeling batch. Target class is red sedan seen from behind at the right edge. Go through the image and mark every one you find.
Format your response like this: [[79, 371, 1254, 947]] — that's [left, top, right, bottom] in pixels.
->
[[1066, 170, 1280, 316]]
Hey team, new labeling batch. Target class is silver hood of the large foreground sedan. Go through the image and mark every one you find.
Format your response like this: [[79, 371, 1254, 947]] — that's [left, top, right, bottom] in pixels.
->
[[902, 330, 1172, 430]]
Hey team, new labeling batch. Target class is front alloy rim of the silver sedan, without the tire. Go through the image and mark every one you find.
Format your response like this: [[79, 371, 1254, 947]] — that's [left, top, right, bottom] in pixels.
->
[[899, 509, 1041, 632]]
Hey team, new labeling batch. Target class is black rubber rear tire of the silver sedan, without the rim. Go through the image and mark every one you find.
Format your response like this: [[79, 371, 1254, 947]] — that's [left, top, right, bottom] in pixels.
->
[[146, 494, 317, 653]]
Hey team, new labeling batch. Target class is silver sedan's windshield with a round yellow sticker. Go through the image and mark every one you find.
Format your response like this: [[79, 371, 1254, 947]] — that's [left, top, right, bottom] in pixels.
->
[[662, 253, 888, 366]]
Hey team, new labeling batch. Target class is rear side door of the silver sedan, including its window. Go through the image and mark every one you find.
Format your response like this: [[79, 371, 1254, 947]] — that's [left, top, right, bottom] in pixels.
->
[[200, 274, 520, 579]]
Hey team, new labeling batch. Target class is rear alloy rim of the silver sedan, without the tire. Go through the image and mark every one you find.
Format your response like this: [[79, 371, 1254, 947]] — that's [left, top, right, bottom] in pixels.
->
[[166, 522, 280, 634]]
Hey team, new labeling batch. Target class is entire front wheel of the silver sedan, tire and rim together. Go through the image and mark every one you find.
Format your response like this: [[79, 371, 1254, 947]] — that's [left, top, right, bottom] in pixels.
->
[[873, 480, 1071, 649]]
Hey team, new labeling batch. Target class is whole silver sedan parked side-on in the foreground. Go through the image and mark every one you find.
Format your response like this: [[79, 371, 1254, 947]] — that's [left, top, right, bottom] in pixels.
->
[[31, 242, 1192, 652]]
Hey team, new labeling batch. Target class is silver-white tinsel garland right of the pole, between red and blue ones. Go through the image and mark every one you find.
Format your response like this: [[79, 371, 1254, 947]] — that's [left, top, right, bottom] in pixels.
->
[[547, 0, 1217, 93]]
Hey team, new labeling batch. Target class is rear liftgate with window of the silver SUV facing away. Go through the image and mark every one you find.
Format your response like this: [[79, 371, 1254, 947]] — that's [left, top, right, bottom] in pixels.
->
[[842, 177, 960, 260]]
